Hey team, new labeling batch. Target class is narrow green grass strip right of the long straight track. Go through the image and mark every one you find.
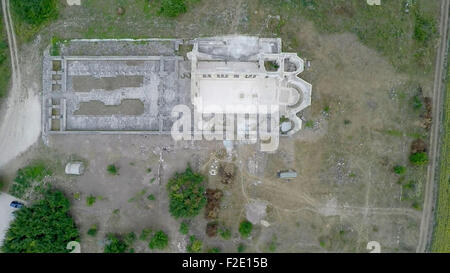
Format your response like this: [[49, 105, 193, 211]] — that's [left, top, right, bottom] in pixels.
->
[[431, 52, 450, 253]]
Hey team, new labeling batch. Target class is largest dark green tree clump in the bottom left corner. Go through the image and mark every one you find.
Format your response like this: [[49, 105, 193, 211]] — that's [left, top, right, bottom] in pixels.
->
[[1, 190, 79, 253]]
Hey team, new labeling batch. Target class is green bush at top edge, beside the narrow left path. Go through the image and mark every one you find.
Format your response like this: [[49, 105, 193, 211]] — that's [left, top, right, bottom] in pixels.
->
[[10, 0, 58, 26]]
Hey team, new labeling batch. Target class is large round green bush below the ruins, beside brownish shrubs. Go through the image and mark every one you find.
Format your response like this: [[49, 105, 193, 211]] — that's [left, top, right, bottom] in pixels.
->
[[167, 167, 206, 218]]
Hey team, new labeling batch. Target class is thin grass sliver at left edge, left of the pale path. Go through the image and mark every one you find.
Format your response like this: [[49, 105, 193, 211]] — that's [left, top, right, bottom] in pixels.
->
[[0, 5, 11, 101]]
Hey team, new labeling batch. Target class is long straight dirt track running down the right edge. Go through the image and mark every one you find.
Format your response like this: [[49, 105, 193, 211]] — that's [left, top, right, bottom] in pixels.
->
[[416, 0, 450, 252]]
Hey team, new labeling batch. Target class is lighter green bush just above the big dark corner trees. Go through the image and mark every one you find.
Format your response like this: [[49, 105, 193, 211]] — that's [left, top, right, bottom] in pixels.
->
[[10, 163, 52, 198]]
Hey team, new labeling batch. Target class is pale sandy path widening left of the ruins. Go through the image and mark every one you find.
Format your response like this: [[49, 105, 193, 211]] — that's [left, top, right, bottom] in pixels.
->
[[0, 0, 41, 167]]
